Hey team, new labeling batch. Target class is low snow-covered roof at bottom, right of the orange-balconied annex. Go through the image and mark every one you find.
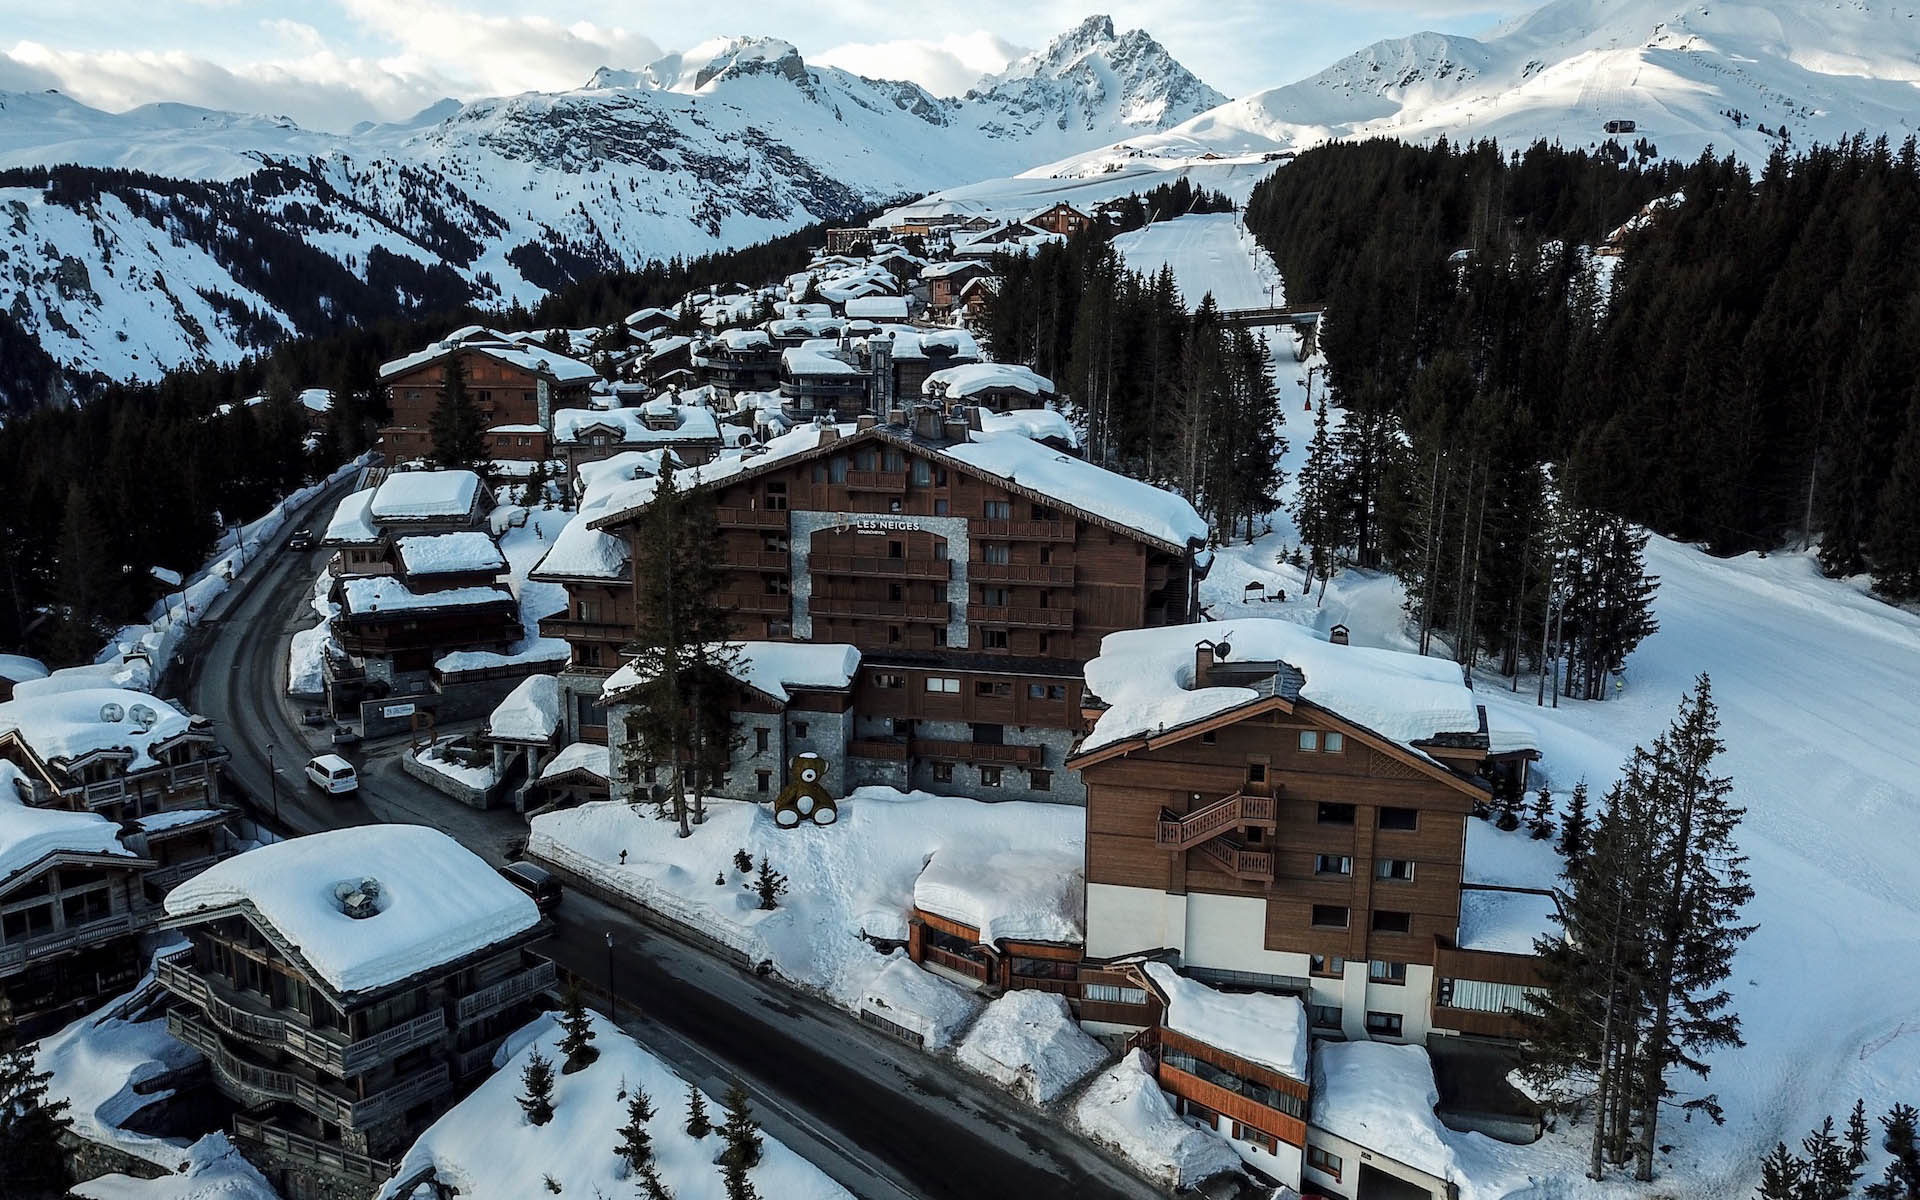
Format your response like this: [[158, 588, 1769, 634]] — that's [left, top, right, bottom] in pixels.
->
[[1313, 1041, 1455, 1179]]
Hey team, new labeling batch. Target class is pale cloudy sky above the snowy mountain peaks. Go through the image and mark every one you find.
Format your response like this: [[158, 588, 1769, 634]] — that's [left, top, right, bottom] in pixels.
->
[[0, 0, 1530, 129]]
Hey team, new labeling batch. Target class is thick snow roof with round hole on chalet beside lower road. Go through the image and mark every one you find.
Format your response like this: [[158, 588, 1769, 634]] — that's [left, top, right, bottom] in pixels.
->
[[167, 826, 540, 993]]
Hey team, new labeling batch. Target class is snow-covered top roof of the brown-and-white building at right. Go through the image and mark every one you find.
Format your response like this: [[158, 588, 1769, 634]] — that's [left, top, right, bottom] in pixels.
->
[[1081, 616, 1480, 753]]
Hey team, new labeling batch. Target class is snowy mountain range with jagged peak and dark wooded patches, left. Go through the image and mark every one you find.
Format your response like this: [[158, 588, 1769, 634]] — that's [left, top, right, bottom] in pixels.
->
[[0, 17, 1221, 393]]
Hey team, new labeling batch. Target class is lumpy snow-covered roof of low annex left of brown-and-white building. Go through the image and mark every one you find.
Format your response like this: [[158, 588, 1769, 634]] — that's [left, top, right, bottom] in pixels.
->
[[914, 845, 1087, 947]]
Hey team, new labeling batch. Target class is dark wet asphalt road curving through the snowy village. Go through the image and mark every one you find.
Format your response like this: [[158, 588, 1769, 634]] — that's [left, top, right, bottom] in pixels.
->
[[186, 474, 1164, 1200]]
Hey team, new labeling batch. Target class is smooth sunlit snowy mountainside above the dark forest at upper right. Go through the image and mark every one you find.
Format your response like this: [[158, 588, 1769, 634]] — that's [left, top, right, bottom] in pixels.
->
[[1021, 0, 1920, 175]]
